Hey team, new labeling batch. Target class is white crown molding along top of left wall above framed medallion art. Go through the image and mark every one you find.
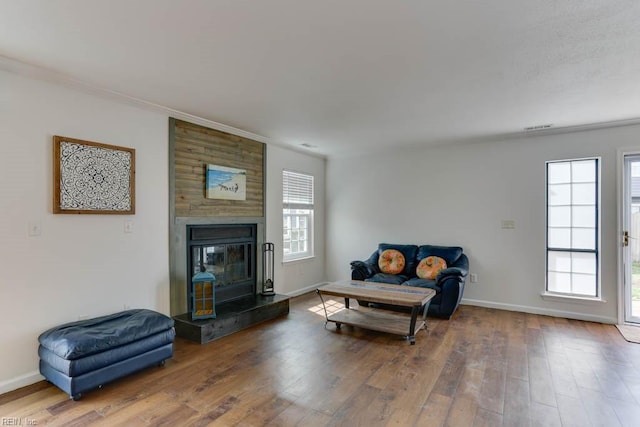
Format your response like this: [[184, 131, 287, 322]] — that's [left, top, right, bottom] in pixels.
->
[[0, 55, 273, 144]]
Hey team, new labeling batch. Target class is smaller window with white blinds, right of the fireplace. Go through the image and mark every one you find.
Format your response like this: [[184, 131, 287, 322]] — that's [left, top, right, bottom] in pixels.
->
[[282, 170, 313, 261]]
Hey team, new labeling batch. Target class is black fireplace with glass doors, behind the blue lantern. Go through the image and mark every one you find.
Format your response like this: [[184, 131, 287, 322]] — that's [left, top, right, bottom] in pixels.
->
[[186, 224, 257, 313]]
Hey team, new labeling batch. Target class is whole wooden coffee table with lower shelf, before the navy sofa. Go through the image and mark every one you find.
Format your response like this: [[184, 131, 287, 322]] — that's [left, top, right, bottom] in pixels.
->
[[316, 280, 436, 345]]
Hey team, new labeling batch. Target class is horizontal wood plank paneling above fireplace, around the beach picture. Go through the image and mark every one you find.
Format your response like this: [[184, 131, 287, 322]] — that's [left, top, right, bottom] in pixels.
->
[[173, 119, 266, 217]]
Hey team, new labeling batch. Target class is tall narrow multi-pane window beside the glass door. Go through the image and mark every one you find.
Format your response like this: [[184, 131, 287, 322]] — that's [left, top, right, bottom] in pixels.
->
[[546, 158, 600, 298]]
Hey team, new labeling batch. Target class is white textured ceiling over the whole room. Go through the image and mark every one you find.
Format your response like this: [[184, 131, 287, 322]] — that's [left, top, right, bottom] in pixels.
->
[[0, 0, 640, 156]]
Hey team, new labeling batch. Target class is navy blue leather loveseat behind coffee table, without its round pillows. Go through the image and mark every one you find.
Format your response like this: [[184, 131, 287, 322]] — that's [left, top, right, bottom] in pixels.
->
[[351, 243, 469, 319]]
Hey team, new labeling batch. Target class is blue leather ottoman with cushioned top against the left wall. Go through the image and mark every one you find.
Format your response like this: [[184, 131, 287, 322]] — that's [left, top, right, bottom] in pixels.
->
[[38, 309, 175, 400]]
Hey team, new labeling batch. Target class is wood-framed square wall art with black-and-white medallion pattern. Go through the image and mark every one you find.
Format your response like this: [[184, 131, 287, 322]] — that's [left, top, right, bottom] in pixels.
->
[[53, 135, 136, 215]]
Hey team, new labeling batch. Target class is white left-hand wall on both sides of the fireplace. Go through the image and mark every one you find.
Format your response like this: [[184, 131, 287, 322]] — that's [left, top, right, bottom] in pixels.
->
[[0, 67, 324, 393]]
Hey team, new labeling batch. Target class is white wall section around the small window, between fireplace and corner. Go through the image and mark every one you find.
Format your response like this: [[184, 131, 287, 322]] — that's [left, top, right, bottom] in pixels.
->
[[266, 145, 326, 295]]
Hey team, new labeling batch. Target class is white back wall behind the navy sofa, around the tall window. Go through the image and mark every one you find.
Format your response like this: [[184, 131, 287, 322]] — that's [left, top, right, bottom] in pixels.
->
[[326, 126, 640, 322]]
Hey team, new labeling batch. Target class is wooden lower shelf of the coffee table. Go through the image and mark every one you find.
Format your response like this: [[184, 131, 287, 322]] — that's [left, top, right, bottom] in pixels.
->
[[327, 307, 426, 344]]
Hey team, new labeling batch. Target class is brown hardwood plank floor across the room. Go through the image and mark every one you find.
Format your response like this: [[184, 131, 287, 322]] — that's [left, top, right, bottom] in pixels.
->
[[0, 294, 640, 427]]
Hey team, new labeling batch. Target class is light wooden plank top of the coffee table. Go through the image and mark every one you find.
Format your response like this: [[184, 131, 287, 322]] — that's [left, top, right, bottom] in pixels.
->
[[318, 280, 436, 307]]
